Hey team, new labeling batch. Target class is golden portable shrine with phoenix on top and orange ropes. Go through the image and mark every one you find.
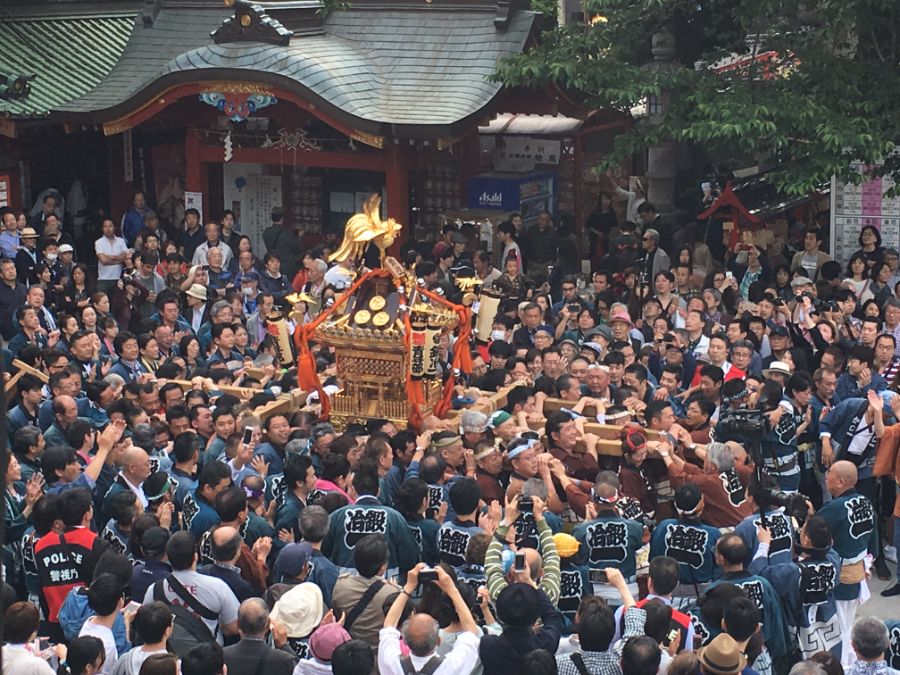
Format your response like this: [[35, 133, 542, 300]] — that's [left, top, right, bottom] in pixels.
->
[[295, 195, 474, 430]]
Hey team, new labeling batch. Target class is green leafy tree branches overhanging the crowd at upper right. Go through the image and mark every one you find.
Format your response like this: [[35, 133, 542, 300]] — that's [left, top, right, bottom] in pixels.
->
[[497, 0, 900, 194]]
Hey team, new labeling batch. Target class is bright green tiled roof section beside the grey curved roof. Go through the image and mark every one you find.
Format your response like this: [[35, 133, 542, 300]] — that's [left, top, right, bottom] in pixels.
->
[[0, 13, 135, 117]]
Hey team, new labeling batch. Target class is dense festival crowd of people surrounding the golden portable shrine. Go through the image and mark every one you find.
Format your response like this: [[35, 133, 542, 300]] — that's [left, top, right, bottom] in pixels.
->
[[0, 193, 900, 675]]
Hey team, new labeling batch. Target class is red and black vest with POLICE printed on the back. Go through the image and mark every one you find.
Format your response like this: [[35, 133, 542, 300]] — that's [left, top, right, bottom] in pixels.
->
[[34, 527, 108, 623]]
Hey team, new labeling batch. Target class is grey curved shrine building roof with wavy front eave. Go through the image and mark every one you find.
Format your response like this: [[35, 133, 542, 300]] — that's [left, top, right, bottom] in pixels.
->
[[57, 0, 535, 136]]
